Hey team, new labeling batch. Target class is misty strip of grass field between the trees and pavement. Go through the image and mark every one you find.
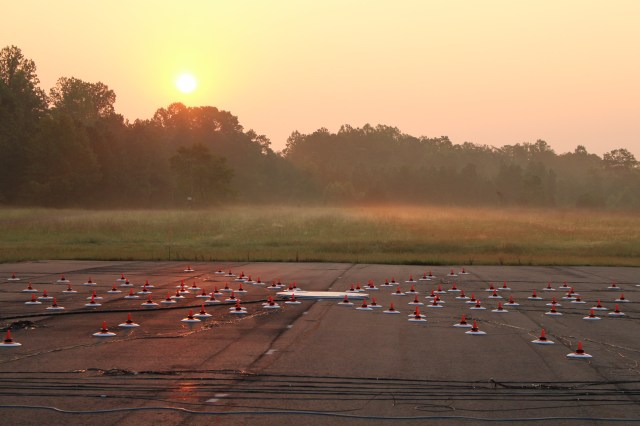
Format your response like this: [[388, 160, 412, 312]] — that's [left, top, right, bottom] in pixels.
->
[[0, 206, 640, 266]]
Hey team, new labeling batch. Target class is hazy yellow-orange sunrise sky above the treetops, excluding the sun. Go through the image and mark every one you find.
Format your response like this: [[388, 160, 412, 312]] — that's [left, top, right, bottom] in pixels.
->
[[0, 0, 640, 158]]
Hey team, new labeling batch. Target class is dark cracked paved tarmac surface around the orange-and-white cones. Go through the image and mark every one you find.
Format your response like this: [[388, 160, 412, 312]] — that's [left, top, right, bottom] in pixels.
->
[[0, 261, 640, 425]]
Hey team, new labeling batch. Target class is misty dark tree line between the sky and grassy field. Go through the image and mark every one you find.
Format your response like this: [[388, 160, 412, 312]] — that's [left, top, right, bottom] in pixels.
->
[[0, 46, 640, 210]]
